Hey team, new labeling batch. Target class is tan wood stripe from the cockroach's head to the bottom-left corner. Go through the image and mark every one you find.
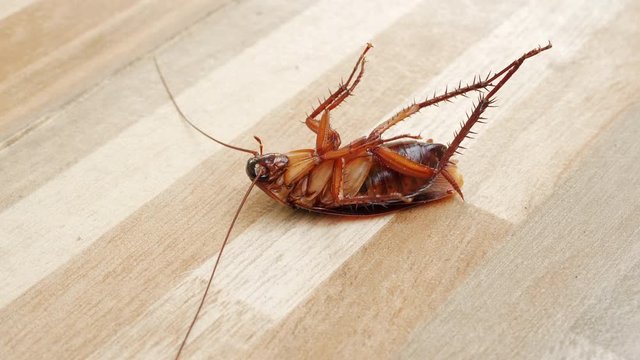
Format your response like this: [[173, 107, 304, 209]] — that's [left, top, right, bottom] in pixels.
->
[[0, 148, 272, 357]]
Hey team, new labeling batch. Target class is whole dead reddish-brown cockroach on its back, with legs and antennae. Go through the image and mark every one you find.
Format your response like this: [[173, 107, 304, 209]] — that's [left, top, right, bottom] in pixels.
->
[[154, 42, 551, 359]]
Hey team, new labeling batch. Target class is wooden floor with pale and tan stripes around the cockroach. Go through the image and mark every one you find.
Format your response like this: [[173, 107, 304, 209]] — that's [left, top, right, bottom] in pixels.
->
[[0, 0, 640, 359]]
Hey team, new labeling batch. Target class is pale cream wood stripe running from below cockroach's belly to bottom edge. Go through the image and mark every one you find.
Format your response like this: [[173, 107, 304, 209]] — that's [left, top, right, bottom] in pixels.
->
[[89, 211, 386, 357]]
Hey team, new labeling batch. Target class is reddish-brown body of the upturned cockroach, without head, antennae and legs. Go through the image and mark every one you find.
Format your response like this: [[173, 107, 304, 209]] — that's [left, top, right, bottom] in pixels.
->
[[257, 141, 462, 216]]
